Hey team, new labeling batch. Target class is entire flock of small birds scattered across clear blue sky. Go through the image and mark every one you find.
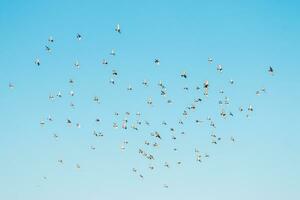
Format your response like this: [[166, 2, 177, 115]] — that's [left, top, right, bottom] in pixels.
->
[[9, 24, 274, 188]]
